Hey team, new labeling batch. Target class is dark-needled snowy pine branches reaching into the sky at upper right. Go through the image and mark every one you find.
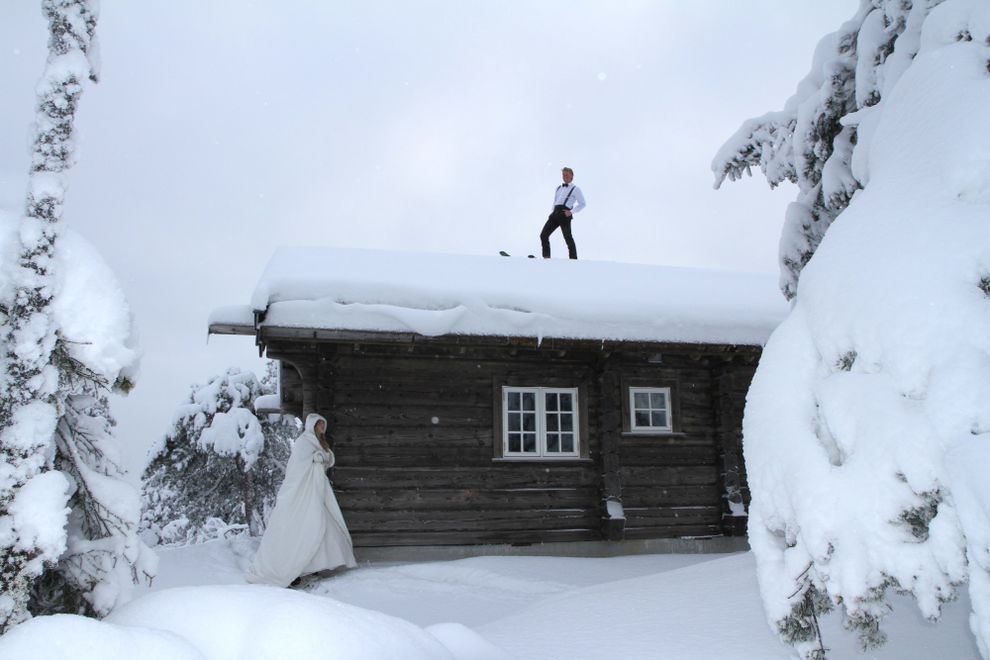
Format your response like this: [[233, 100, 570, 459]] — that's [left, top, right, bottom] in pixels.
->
[[712, 0, 924, 300]]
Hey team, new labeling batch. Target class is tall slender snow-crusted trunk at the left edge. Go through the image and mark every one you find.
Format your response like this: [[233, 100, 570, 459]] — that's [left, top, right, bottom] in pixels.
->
[[0, 0, 96, 633]]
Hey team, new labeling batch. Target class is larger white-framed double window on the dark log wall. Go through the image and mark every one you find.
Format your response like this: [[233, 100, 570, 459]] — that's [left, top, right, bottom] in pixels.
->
[[502, 387, 580, 458]]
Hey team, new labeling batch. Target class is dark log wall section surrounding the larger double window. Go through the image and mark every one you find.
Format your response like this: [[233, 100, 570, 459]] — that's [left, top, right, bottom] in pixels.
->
[[327, 345, 601, 546]]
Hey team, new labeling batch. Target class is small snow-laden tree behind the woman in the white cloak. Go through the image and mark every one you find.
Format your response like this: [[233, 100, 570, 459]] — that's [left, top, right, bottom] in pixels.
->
[[142, 363, 299, 543]]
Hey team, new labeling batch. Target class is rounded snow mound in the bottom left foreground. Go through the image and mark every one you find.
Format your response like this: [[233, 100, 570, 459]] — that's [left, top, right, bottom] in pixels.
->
[[0, 585, 492, 660]]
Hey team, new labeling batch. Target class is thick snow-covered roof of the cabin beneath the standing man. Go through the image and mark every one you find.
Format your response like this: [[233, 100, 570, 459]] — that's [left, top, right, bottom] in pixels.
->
[[210, 247, 788, 345]]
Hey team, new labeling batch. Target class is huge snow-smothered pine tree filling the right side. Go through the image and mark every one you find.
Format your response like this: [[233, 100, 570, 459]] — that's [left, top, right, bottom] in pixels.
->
[[716, 0, 990, 659]]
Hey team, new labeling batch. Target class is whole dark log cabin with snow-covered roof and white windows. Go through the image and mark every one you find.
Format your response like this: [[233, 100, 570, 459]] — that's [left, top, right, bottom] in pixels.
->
[[209, 247, 787, 549]]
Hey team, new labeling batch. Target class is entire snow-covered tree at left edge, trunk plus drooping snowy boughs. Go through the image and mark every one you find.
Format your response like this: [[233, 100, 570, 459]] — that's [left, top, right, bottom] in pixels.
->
[[0, 0, 156, 629]]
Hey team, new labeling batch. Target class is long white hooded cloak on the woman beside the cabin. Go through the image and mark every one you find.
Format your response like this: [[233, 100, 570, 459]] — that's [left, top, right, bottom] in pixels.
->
[[247, 414, 357, 587]]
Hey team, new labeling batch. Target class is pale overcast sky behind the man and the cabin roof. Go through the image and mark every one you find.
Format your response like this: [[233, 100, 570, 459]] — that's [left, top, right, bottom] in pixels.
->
[[0, 0, 858, 468]]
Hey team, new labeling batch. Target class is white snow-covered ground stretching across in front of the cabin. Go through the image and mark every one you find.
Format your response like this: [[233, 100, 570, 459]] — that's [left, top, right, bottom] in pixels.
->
[[0, 538, 979, 660]]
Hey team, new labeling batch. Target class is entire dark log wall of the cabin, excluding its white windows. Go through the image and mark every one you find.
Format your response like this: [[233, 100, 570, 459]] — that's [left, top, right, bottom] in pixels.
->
[[269, 338, 758, 546]]
